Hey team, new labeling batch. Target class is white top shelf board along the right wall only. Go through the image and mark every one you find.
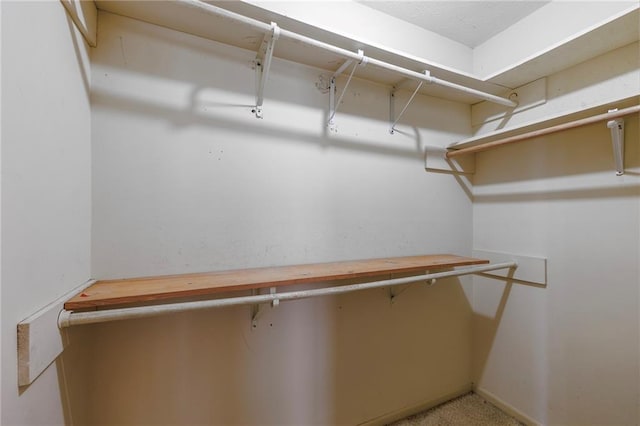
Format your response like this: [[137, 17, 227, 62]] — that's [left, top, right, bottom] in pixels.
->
[[483, 3, 640, 87]]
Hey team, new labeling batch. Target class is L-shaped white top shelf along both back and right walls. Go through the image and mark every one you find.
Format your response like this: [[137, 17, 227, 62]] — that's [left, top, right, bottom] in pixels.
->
[[96, 0, 640, 104]]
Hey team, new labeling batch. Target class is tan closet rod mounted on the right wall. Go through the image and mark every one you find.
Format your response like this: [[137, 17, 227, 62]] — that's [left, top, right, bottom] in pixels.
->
[[445, 105, 640, 158]]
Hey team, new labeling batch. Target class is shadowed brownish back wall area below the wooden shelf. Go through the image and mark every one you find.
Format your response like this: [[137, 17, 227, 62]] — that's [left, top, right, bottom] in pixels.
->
[[58, 279, 470, 425]]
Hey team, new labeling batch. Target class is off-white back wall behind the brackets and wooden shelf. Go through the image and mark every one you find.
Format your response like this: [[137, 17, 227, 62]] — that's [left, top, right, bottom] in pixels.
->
[[87, 13, 471, 425]]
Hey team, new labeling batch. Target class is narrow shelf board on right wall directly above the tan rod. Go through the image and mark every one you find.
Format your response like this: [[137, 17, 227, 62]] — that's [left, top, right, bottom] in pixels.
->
[[447, 96, 640, 149]]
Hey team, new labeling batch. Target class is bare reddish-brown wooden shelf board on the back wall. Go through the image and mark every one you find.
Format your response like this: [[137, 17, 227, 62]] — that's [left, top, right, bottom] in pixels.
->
[[64, 254, 489, 311]]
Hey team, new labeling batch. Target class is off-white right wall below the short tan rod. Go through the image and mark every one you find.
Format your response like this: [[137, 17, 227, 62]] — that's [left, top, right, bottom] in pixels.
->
[[473, 56, 640, 425]]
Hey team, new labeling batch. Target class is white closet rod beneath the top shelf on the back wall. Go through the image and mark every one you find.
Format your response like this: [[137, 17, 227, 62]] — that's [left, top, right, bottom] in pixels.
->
[[178, 0, 518, 108]]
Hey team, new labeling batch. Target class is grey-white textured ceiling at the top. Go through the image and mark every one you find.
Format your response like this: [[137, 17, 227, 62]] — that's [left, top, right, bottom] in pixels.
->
[[359, 0, 548, 48]]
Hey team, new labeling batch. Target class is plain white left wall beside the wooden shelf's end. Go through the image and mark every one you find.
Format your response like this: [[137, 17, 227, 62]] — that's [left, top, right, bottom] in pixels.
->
[[1, 2, 91, 425]]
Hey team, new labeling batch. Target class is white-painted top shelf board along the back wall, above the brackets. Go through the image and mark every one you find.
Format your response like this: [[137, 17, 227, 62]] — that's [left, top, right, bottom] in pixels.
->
[[96, 0, 507, 104]]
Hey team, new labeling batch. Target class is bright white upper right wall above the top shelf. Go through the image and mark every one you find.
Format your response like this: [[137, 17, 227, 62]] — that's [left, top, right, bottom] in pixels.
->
[[473, 1, 638, 78]]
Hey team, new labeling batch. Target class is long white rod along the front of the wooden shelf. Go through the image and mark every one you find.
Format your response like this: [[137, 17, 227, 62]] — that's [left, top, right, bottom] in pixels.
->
[[58, 262, 518, 328]]
